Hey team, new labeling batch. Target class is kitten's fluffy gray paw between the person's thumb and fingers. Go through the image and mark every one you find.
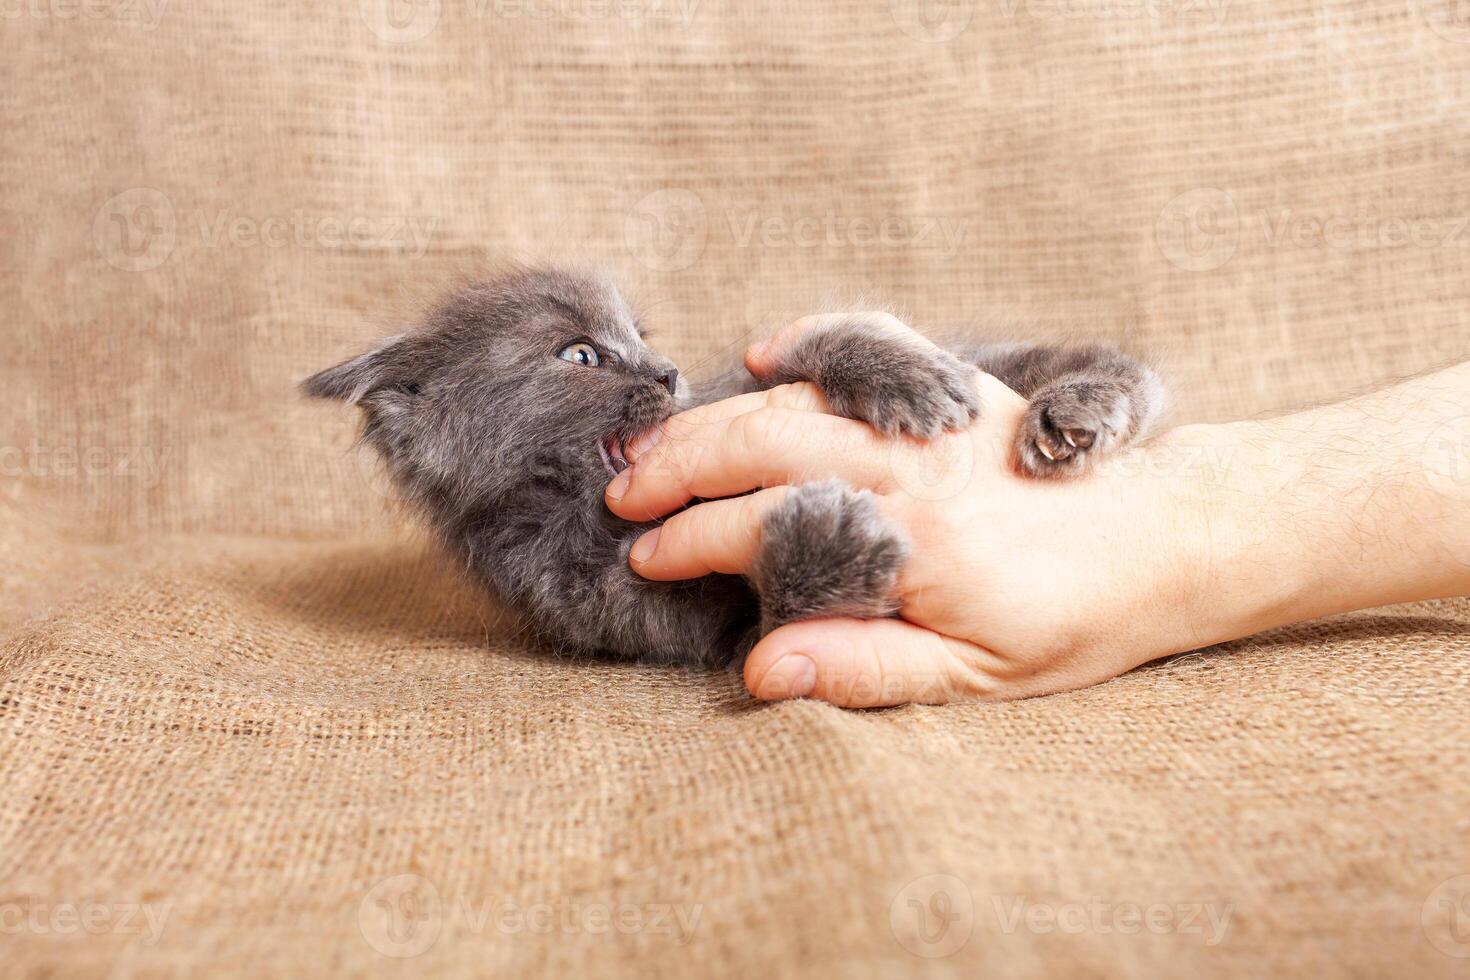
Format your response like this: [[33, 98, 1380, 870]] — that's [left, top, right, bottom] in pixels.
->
[[750, 480, 908, 635]]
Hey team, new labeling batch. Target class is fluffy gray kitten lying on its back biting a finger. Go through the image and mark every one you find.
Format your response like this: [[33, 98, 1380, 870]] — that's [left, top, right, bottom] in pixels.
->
[[303, 269, 1161, 664]]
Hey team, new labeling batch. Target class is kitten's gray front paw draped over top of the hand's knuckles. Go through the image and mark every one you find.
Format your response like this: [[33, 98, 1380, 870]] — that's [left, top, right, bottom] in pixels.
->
[[782, 314, 980, 439]]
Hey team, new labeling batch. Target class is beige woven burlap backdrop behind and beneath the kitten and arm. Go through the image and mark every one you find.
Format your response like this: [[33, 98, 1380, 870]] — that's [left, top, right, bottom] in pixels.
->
[[0, 0, 1470, 979]]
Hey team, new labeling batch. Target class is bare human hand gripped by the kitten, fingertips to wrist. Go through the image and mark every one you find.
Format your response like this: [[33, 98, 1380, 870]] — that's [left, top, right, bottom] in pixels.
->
[[607, 317, 1192, 705]]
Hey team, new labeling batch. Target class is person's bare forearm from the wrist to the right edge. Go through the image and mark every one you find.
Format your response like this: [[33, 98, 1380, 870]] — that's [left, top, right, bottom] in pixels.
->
[[1161, 364, 1470, 642]]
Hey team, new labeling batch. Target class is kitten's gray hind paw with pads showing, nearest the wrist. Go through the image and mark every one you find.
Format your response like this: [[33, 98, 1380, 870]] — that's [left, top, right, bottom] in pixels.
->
[[1016, 381, 1139, 476]]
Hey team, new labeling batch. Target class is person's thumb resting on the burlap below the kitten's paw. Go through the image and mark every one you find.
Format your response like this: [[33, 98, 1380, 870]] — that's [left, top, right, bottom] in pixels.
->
[[745, 619, 1000, 708]]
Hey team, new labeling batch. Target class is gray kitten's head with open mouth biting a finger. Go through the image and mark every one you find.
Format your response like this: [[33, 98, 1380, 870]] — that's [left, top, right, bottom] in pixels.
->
[[301, 269, 682, 508]]
